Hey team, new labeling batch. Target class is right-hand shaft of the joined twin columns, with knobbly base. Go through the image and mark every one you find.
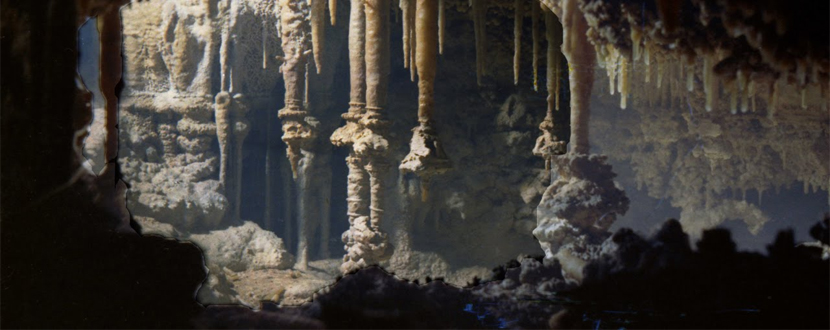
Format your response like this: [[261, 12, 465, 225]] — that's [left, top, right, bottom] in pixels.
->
[[340, 0, 394, 272]]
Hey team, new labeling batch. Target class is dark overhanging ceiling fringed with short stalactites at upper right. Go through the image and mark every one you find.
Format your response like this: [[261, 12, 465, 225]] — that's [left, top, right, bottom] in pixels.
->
[[580, 0, 830, 115]]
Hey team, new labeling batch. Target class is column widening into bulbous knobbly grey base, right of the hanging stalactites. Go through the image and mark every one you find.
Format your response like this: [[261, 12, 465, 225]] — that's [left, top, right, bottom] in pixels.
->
[[533, 0, 629, 282]]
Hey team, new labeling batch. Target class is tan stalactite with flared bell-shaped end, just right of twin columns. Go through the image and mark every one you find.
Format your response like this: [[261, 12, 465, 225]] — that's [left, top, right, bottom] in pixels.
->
[[399, 0, 451, 198]]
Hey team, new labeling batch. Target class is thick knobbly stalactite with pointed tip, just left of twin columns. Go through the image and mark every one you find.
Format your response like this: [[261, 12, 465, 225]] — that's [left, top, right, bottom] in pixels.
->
[[279, 0, 316, 179]]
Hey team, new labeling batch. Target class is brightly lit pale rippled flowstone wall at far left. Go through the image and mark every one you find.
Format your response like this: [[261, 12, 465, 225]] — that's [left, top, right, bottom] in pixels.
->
[[119, 0, 279, 230]]
